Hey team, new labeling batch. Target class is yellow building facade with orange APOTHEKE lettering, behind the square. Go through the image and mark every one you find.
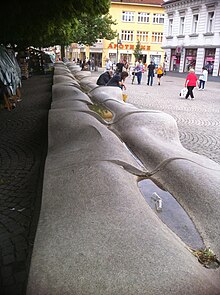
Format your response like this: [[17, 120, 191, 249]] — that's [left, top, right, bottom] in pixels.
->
[[71, 0, 164, 67]]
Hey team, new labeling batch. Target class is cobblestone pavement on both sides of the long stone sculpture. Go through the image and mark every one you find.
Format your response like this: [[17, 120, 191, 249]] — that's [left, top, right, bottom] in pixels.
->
[[0, 72, 220, 295]]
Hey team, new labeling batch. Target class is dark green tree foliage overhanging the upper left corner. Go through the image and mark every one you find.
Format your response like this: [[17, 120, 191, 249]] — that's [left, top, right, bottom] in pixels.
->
[[0, 0, 111, 47]]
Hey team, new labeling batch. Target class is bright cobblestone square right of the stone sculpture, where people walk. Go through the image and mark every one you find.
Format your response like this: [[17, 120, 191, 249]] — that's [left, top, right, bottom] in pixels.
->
[[126, 73, 220, 164]]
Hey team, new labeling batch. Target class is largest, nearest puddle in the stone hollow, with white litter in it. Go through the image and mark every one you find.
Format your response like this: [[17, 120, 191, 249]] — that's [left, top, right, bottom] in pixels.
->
[[138, 179, 205, 249]]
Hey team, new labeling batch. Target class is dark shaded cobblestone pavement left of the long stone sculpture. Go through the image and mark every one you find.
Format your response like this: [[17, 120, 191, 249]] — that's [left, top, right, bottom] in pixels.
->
[[0, 75, 52, 295]]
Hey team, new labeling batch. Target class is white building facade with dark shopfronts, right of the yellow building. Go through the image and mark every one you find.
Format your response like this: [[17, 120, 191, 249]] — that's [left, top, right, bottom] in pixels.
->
[[162, 0, 220, 76]]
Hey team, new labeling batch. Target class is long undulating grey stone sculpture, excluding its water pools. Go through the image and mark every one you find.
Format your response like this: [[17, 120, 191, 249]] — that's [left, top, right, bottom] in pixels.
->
[[27, 63, 220, 295]]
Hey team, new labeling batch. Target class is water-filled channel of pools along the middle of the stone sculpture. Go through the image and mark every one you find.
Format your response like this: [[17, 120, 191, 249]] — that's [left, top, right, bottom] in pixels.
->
[[89, 104, 220, 269]]
